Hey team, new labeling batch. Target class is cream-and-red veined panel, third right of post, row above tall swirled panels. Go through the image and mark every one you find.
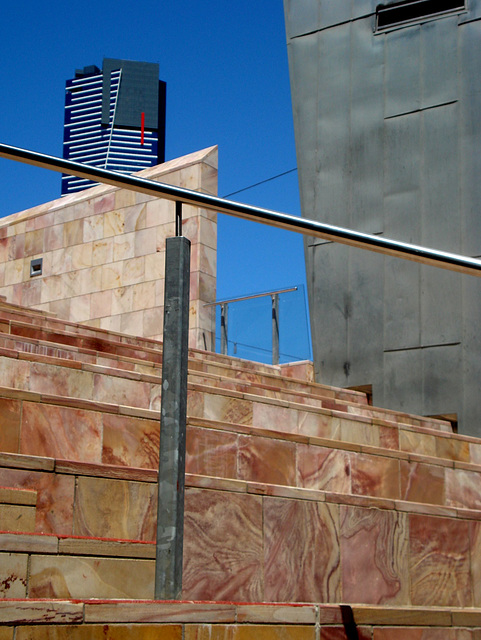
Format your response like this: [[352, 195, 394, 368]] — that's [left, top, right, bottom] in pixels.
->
[[297, 444, 351, 493]]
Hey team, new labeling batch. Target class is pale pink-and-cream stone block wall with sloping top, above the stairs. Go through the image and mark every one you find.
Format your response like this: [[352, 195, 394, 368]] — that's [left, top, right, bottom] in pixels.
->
[[0, 147, 217, 349]]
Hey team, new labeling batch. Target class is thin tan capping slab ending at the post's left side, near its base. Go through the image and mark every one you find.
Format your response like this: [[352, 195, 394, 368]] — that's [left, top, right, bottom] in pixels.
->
[[58, 538, 155, 559]]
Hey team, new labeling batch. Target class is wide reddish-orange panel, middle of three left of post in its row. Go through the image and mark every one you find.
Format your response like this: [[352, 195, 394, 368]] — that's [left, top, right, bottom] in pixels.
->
[[20, 402, 102, 463]]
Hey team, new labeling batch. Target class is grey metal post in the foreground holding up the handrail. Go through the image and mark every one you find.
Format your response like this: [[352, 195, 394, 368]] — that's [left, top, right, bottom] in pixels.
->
[[155, 230, 190, 600]]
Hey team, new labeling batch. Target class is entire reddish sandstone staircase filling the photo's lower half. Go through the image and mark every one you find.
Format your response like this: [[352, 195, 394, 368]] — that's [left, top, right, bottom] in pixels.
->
[[0, 301, 481, 640]]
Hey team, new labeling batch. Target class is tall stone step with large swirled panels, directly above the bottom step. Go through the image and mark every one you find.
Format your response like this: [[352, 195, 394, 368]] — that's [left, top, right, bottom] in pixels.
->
[[0, 454, 481, 607]]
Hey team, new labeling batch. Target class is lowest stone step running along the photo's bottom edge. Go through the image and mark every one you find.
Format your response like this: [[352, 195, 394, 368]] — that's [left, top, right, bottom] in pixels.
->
[[0, 599, 481, 640]]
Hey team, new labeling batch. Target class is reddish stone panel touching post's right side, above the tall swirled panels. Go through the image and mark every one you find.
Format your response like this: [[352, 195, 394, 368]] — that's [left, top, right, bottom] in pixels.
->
[[185, 426, 238, 478]]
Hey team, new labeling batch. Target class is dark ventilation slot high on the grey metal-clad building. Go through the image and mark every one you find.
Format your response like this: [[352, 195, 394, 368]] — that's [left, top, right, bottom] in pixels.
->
[[376, 0, 465, 30]]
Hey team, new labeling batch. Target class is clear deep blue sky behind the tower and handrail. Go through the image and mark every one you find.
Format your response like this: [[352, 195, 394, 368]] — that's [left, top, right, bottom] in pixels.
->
[[0, 0, 305, 360]]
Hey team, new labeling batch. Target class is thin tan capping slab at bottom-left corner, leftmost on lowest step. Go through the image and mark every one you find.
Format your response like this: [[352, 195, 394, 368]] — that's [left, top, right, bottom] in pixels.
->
[[0, 600, 84, 625]]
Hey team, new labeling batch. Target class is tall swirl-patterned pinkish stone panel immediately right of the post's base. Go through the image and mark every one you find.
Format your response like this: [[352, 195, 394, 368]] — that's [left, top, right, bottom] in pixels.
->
[[182, 489, 264, 602]]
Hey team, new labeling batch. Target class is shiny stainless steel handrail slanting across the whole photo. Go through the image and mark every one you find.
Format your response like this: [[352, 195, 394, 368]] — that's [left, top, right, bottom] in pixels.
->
[[0, 144, 481, 277]]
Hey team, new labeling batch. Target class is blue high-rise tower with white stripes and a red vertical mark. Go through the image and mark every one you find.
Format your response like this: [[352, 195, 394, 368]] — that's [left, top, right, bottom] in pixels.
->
[[62, 58, 165, 195]]
